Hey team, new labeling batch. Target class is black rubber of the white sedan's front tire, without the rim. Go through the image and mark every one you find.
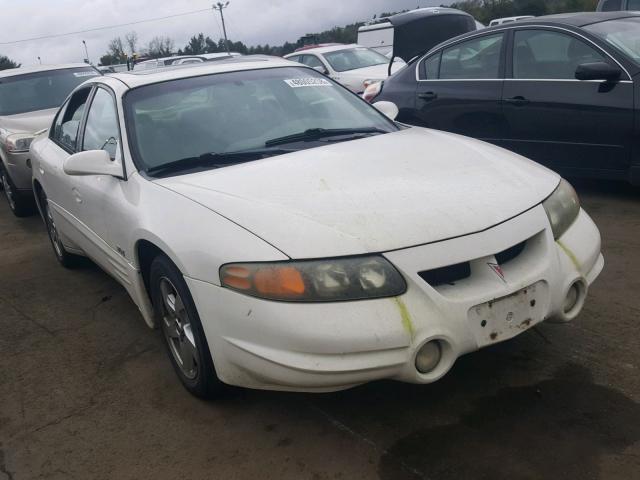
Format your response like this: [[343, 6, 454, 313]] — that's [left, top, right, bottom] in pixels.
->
[[149, 255, 222, 399]]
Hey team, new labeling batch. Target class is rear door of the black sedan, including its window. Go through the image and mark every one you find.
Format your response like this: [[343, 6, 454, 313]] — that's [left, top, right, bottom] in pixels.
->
[[413, 32, 506, 143]]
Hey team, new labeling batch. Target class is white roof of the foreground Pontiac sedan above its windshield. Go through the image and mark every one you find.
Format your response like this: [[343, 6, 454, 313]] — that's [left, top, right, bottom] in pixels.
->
[[110, 55, 300, 88]]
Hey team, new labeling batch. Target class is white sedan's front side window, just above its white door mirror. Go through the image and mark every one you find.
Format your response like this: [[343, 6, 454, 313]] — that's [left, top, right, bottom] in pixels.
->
[[82, 88, 120, 160]]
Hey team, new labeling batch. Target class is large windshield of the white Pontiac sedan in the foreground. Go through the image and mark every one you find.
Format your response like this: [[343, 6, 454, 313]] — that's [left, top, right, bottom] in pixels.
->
[[124, 67, 398, 171]]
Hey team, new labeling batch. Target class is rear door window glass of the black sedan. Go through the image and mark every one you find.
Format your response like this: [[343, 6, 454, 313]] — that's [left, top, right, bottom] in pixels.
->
[[439, 33, 504, 80]]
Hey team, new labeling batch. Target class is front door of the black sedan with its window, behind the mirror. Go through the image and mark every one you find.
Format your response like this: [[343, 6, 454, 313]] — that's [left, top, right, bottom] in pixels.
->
[[503, 27, 633, 176]]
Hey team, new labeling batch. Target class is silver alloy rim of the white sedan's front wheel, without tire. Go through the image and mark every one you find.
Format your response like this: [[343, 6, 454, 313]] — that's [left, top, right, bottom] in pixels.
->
[[160, 277, 198, 380]]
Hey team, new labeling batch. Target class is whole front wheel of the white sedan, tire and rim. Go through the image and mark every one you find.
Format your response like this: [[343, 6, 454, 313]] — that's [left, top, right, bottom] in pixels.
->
[[149, 255, 224, 399]]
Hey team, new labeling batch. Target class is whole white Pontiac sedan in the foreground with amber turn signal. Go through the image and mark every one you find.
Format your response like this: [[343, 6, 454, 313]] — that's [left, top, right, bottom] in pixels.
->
[[31, 57, 604, 397]]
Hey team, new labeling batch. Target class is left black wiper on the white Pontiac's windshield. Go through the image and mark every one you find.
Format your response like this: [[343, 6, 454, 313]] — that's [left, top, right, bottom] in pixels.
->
[[145, 148, 295, 174]]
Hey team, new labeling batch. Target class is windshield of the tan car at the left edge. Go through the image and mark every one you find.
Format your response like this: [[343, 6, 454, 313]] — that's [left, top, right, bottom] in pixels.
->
[[0, 67, 100, 115]]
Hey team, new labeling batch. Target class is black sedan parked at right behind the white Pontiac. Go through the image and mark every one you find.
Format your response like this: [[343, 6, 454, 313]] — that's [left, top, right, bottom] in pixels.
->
[[372, 12, 640, 184]]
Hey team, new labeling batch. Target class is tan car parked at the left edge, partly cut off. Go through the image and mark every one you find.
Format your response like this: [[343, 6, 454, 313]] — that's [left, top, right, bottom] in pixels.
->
[[0, 63, 100, 217]]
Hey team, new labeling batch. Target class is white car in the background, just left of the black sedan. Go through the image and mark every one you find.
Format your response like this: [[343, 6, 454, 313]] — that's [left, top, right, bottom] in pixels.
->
[[284, 44, 404, 94]]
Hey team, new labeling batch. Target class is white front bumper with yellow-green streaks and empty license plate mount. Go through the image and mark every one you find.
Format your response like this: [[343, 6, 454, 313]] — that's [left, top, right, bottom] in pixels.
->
[[187, 206, 604, 391]]
